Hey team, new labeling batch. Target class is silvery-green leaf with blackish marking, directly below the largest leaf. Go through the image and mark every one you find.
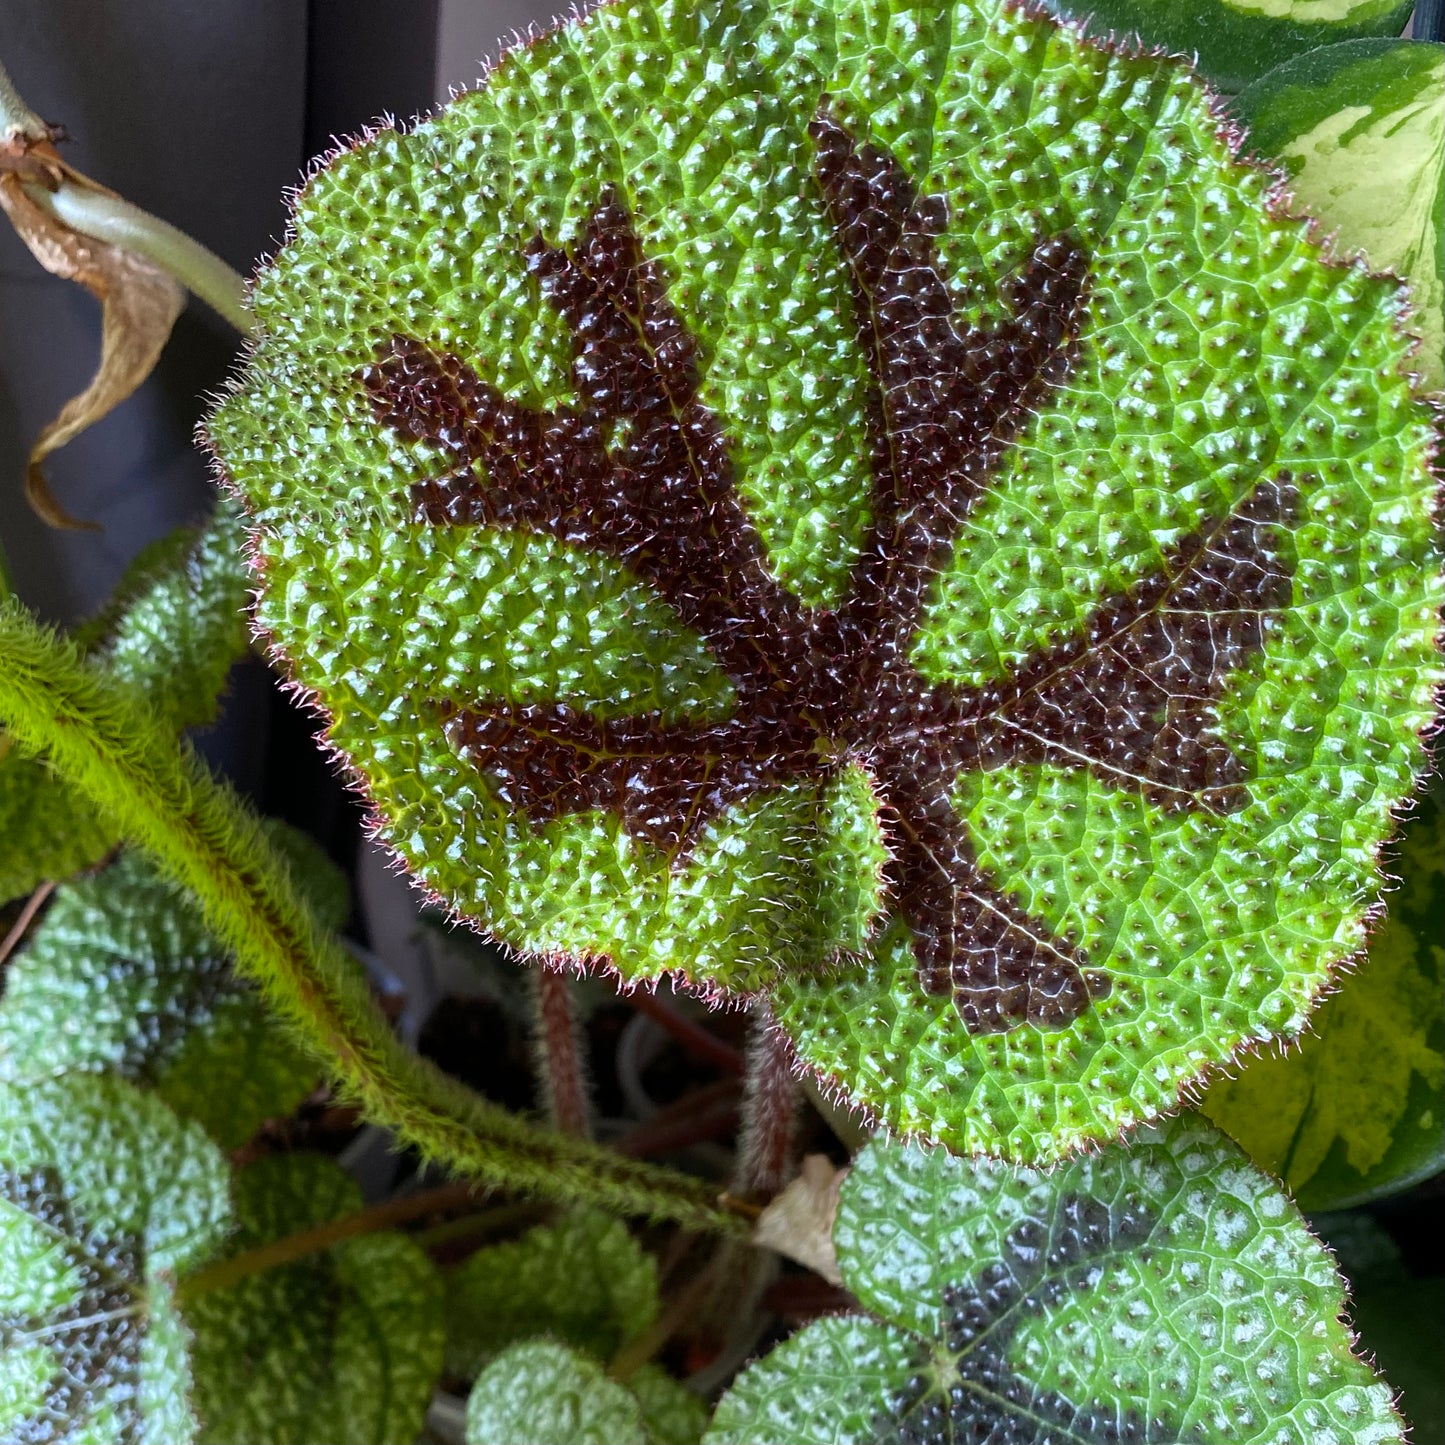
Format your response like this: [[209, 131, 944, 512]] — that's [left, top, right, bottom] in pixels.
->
[[705, 1114, 1402, 1445]]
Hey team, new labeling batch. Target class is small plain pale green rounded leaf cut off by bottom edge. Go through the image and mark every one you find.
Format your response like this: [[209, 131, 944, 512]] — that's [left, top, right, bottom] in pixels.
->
[[467, 1340, 652, 1445]]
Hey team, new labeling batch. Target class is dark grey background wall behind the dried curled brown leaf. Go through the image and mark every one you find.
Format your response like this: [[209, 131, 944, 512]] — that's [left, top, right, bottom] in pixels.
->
[[0, 0, 436, 858]]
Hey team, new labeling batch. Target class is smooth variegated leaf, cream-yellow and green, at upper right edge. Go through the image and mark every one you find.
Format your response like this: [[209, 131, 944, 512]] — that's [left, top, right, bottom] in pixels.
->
[[1234, 40, 1445, 392]]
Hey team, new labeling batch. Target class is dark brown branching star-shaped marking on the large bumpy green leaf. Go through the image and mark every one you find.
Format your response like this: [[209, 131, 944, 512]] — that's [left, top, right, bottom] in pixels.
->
[[361, 104, 1295, 1033]]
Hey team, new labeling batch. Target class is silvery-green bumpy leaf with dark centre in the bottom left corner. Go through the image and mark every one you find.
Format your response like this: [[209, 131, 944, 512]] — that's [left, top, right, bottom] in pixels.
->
[[0, 1074, 228, 1445]]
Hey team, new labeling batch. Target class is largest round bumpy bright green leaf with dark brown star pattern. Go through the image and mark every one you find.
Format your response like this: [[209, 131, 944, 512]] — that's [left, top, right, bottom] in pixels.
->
[[212, 0, 1441, 1159]]
